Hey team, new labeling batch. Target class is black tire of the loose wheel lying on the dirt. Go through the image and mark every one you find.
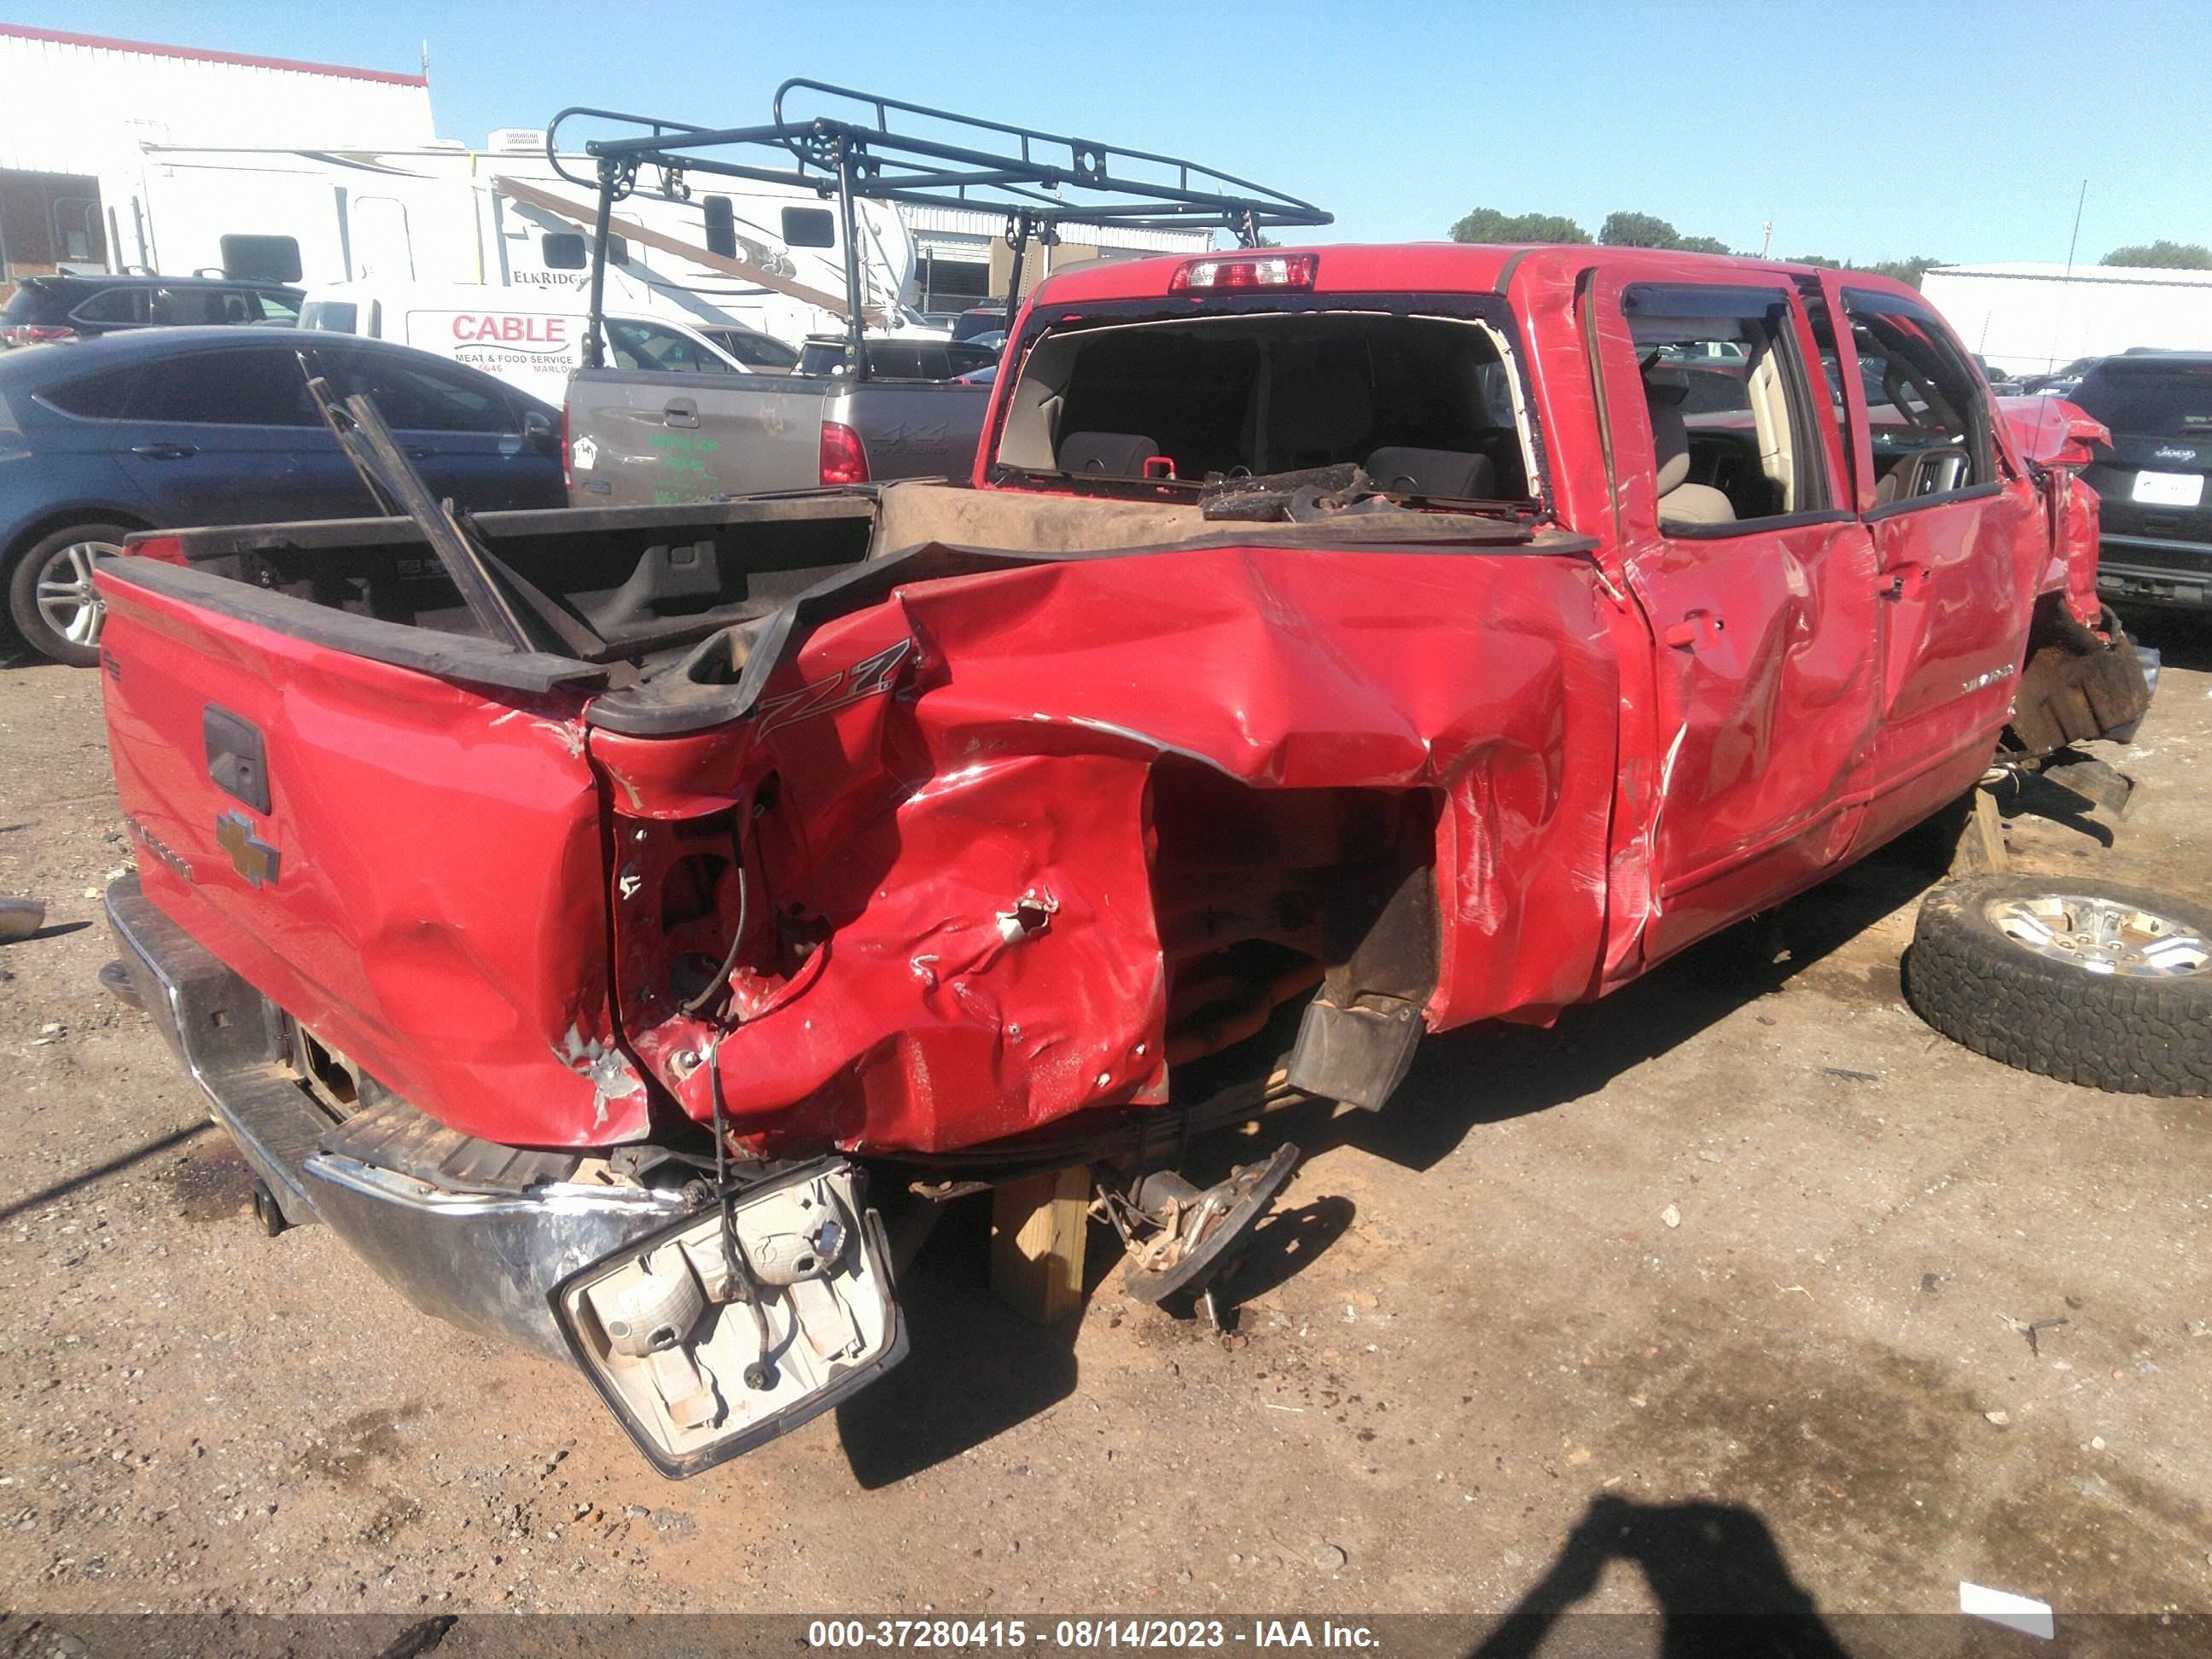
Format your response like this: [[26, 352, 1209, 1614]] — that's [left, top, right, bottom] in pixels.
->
[[1905, 876, 2212, 1095]]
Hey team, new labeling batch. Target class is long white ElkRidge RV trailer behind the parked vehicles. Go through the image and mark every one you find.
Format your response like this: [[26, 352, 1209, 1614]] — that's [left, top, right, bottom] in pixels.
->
[[100, 141, 918, 343]]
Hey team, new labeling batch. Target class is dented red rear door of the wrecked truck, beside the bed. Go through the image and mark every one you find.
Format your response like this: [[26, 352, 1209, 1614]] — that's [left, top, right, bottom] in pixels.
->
[[1586, 276, 1876, 958]]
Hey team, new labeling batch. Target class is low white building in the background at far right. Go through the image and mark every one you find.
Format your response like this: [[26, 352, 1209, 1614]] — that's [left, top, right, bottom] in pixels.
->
[[1920, 263, 2212, 374]]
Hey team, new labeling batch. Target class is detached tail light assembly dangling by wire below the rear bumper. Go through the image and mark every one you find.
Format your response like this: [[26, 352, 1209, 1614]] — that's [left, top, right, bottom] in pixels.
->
[[550, 1159, 907, 1480]]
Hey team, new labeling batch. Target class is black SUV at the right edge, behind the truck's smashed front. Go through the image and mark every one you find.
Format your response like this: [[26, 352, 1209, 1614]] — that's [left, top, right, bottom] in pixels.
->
[[2073, 352, 2212, 610]]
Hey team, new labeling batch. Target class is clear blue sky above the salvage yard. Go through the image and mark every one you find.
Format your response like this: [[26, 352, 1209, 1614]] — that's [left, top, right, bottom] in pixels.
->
[[17, 0, 2212, 261]]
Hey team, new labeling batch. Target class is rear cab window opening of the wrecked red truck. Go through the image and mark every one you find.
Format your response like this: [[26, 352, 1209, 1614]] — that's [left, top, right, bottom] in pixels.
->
[[993, 294, 1544, 511]]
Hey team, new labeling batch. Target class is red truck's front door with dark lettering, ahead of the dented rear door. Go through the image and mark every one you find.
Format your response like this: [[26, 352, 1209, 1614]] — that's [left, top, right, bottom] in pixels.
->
[[1823, 274, 2051, 843]]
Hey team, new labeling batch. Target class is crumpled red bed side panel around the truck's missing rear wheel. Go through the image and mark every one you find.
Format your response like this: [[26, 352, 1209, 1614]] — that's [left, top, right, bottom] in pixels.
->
[[593, 549, 1617, 1152]]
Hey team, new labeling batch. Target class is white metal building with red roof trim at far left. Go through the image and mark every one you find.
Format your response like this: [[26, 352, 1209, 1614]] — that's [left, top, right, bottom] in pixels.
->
[[0, 22, 436, 294]]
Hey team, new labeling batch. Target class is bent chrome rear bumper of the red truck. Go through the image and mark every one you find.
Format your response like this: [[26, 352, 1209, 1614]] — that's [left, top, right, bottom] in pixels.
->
[[106, 876, 684, 1363]]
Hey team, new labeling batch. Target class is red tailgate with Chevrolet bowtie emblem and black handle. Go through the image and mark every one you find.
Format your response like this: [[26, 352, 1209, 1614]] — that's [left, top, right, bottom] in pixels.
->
[[100, 560, 646, 1146]]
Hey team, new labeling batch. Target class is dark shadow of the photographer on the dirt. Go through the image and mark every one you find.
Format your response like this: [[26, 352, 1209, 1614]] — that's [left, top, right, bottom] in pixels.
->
[[1471, 1495, 1849, 1659]]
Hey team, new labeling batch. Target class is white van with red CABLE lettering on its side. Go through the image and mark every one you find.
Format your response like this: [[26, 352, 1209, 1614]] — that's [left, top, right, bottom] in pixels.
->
[[299, 283, 748, 407]]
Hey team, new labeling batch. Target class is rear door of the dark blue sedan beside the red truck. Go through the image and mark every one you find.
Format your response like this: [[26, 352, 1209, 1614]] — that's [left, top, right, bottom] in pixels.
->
[[115, 341, 371, 527]]
